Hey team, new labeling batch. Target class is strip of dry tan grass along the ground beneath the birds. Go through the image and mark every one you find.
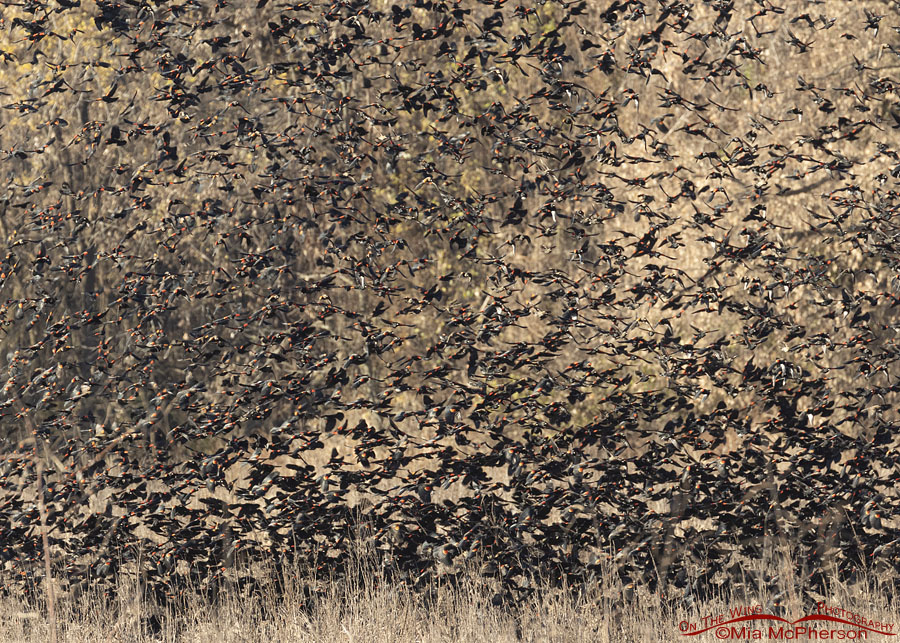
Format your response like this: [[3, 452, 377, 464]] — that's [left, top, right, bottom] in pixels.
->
[[0, 552, 900, 643]]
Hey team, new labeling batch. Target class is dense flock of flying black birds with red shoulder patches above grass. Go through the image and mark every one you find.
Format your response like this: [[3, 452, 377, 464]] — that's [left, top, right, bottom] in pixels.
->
[[0, 0, 900, 604]]
